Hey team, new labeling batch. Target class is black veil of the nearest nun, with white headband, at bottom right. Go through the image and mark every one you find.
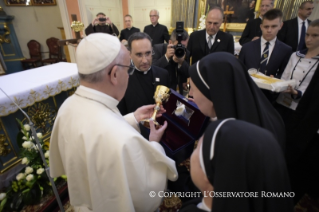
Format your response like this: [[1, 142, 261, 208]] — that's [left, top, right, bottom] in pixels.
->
[[202, 120, 293, 212]]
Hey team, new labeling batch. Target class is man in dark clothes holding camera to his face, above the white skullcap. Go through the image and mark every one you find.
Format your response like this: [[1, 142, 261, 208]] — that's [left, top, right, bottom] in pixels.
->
[[85, 12, 119, 36]]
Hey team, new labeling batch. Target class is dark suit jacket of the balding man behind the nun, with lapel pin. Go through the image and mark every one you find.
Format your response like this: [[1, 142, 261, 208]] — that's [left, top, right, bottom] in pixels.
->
[[187, 29, 234, 64]]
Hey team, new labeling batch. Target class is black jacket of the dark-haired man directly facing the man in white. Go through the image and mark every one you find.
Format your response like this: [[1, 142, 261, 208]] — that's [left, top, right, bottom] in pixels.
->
[[117, 66, 168, 116]]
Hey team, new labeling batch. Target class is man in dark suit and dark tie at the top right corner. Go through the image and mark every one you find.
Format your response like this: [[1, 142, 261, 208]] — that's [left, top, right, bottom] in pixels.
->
[[278, 1, 314, 52]]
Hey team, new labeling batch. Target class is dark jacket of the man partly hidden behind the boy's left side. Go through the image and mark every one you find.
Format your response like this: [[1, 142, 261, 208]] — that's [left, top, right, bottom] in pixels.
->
[[239, 18, 262, 45]]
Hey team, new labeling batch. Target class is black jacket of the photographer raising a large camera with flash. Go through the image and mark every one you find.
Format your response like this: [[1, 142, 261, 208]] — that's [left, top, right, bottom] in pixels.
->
[[152, 43, 189, 95]]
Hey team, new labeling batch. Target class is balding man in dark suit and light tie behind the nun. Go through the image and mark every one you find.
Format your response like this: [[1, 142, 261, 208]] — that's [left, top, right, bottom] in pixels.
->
[[187, 6, 234, 64]]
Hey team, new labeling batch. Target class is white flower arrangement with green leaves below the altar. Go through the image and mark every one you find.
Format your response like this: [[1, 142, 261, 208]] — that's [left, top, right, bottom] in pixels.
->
[[0, 119, 66, 212]]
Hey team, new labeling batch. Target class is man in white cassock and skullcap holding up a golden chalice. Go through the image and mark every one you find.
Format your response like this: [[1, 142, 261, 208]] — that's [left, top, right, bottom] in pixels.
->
[[50, 33, 177, 212]]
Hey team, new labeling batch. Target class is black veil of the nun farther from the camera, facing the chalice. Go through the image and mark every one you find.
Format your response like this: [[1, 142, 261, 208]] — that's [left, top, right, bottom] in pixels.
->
[[189, 52, 285, 150]]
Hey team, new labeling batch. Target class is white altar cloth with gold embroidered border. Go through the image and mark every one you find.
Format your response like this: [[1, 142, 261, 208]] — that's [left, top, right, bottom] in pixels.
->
[[0, 62, 79, 117]]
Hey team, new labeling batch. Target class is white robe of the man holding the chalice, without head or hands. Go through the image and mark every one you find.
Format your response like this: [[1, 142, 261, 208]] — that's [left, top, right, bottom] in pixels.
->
[[50, 86, 177, 212]]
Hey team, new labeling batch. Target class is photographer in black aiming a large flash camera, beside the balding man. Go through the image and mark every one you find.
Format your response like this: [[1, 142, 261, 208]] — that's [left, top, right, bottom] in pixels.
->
[[153, 28, 189, 95]]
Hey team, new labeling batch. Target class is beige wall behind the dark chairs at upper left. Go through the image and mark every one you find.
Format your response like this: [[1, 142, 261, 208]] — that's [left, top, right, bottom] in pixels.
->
[[0, 1, 63, 58]]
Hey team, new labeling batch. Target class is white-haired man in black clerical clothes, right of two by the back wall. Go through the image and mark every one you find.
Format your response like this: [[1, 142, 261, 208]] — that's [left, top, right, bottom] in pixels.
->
[[144, 10, 169, 46]]
